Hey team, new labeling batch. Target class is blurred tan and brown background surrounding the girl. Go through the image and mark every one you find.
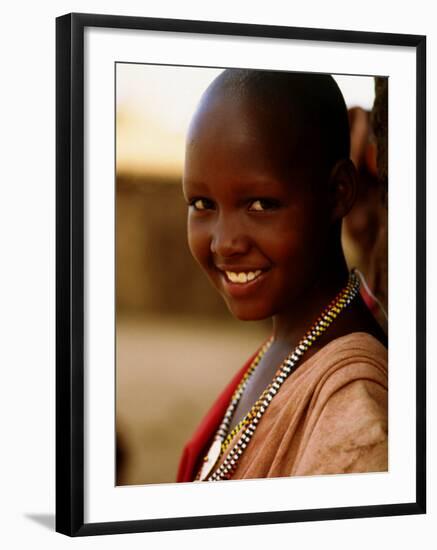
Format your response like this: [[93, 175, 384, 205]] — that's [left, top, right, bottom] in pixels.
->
[[116, 63, 388, 485]]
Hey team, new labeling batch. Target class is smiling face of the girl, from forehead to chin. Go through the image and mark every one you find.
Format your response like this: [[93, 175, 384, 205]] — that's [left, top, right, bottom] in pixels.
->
[[183, 93, 330, 320]]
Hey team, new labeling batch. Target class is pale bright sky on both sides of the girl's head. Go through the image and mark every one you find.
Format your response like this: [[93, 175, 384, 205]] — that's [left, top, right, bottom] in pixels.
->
[[116, 63, 374, 175]]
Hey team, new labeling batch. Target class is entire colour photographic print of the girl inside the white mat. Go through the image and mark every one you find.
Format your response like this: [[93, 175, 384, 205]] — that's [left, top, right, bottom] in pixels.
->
[[116, 63, 388, 484]]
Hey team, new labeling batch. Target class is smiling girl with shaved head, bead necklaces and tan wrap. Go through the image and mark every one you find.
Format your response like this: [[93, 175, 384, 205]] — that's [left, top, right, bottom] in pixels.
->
[[178, 69, 388, 481]]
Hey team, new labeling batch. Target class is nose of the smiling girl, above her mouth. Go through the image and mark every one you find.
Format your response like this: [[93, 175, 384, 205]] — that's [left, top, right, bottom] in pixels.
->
[[210, 213, 250, 258]]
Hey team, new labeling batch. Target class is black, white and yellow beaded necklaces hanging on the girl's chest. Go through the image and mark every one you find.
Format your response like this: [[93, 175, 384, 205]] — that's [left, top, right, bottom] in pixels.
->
[[196, 270, 360, 481]]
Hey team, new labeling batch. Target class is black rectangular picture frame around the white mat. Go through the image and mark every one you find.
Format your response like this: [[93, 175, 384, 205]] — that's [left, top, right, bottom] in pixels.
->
[[56, 13, 426, 536]]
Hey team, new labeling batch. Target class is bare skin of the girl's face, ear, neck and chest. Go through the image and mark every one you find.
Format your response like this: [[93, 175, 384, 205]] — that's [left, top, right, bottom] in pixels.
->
[[183, 89, 386, 434]]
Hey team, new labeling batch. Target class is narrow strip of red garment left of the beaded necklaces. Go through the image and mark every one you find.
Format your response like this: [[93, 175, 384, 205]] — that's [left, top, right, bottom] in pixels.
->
[[176, 350, 258, 483]]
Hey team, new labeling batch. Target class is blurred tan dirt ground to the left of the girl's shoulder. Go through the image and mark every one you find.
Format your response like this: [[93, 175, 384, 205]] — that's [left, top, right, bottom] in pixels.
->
[[116, 316, 268, 485]]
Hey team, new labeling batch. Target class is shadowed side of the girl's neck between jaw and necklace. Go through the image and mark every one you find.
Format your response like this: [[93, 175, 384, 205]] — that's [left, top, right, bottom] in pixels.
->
[[273, 246, 349, 346]]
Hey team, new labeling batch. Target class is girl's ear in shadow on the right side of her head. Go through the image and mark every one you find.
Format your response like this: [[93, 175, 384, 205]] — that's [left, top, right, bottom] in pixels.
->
[[328, 159, 357, 222]]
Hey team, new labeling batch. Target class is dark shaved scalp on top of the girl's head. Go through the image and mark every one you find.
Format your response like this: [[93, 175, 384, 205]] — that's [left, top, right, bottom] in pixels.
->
[[193, 69, 350, 183]]
